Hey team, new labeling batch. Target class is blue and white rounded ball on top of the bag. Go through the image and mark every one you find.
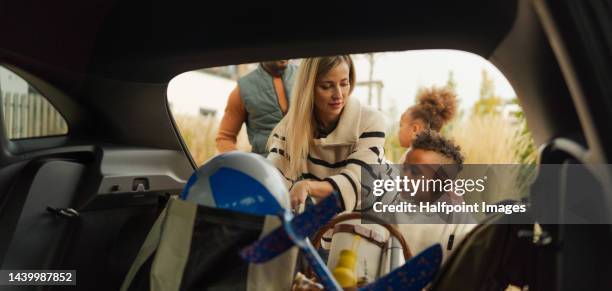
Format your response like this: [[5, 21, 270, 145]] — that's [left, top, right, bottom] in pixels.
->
[[181, 151, 290, 215]]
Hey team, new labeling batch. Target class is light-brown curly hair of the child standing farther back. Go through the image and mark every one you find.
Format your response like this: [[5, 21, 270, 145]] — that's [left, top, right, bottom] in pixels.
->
[[409, 86, 457, 131]]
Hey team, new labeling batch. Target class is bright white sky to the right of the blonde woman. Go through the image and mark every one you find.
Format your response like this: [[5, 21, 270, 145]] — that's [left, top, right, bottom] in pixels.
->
[[355, 50, 516, 117]]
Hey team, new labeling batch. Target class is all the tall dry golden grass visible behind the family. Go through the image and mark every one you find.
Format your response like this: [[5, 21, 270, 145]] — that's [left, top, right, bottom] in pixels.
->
[[174, 114, 536, 202]]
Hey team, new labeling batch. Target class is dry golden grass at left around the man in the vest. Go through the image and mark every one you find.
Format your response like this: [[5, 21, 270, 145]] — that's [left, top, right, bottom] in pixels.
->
[[174, 114, 251, 166]]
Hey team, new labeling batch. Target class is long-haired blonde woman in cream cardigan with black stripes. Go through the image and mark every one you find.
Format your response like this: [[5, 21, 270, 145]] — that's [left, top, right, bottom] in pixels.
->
[[268, 55, 385, 211]]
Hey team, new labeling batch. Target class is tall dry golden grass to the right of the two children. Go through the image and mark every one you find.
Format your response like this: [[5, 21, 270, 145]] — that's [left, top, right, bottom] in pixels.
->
[[445, 114, 537, 206]]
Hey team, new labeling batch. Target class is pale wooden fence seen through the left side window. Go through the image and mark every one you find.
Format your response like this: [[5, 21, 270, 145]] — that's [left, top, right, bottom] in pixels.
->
[[2, 92, 68, 139]]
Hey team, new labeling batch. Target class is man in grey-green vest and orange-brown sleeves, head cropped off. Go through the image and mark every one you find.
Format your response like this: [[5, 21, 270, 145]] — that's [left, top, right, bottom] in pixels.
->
[[216, 60, 297, 157]]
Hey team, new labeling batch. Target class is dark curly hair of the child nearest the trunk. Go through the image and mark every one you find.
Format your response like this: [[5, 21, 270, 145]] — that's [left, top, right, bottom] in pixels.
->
[[412, 130, 463, 169]]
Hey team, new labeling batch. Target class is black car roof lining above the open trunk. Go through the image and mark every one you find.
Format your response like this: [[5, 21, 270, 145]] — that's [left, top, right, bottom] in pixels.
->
[[0, 0, 516, 83]]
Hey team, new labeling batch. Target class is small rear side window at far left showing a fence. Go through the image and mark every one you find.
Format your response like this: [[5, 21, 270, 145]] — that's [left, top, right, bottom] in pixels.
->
[[0, 66, 68, 139]]
